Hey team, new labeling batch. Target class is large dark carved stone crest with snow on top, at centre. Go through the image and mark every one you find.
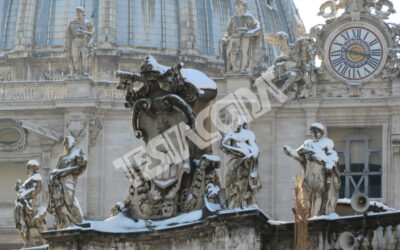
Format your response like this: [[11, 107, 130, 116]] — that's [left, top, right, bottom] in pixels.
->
[[111, 56, 219, 219]]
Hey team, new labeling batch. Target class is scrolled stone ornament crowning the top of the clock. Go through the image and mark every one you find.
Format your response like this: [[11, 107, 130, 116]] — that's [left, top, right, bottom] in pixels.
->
[[318, 0, 395, 21]]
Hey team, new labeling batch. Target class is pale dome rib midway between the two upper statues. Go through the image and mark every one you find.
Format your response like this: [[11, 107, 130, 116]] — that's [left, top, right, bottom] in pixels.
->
[[178, 0, 198, 55]]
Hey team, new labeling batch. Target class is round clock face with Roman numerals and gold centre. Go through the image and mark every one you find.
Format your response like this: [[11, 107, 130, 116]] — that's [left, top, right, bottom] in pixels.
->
[[324, 22, 387, 83]]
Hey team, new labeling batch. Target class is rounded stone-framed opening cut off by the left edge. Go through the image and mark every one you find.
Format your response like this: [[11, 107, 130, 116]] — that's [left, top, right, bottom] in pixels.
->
[[0, 119, 26, 152]]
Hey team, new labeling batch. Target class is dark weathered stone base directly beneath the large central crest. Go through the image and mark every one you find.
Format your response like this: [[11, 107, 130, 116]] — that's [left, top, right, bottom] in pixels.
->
[[44, 209, 268, 250]]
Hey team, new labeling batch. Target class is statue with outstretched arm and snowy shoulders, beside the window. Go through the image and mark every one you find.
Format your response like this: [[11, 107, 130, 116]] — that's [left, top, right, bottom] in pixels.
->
[[283, 123, 340, 217]]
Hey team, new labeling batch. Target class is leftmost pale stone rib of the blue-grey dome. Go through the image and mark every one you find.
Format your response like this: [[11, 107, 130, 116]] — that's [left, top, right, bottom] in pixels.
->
[[14, 0, 37, 50]]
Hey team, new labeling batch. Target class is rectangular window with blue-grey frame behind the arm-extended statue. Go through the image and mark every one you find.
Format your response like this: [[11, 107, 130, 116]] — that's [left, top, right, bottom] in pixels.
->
[[329, 128, 382, 198]]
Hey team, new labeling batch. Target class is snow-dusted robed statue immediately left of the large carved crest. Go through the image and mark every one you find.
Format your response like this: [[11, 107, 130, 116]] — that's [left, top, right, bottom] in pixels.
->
[[47, 136, 87, 229]]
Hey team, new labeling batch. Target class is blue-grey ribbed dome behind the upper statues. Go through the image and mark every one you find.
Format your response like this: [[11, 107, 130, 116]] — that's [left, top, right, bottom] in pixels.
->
[[0, 0, 297, 63]]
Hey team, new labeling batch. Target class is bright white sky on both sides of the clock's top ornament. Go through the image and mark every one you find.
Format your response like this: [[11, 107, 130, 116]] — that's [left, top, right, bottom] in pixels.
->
[[293, 0, 400, 31]]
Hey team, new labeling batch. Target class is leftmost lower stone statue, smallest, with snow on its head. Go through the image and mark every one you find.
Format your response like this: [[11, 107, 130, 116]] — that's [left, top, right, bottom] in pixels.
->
[[14, 160, 47, 247]]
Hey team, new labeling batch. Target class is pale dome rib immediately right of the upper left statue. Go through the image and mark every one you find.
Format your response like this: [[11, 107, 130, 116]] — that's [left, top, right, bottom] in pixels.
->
[[96, 0, 117, 48]]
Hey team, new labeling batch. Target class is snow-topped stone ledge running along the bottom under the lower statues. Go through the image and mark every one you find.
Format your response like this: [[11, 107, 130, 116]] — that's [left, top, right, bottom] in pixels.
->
[[40, 204, 400, 250]]
